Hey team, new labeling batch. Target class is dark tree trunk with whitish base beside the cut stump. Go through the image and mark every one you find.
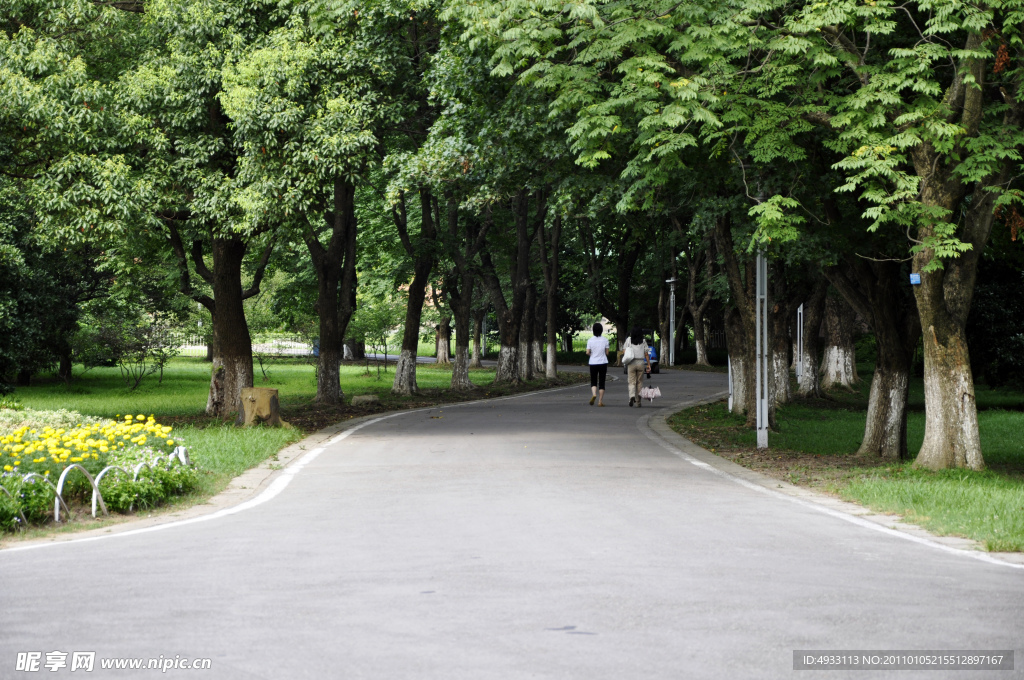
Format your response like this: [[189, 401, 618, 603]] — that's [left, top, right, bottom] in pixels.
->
[[206, 238, 253, 418]]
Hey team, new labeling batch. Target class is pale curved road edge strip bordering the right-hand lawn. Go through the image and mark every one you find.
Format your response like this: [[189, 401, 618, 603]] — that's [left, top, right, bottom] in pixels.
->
[[637, 392, 1024, 569]]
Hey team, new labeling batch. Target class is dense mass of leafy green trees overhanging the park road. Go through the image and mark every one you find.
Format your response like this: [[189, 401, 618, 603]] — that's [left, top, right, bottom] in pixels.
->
[[0, 0, 1024, 468]]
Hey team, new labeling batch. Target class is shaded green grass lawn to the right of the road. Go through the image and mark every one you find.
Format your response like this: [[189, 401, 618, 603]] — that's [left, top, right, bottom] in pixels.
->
[[669, 371, 1024, 551]]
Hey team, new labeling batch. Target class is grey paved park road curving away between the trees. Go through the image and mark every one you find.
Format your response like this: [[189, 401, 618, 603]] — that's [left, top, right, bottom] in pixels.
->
[[0, 373, 1024, 680]]
